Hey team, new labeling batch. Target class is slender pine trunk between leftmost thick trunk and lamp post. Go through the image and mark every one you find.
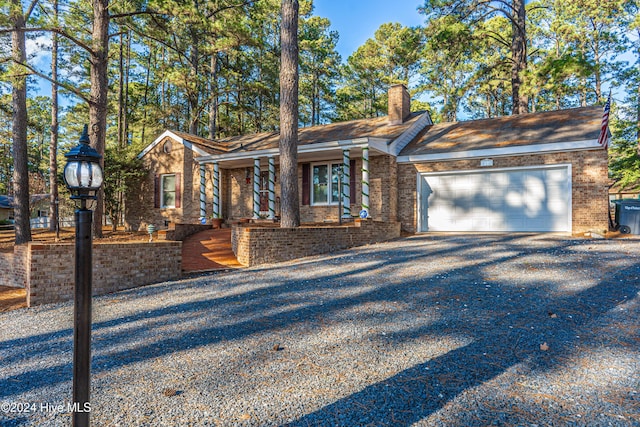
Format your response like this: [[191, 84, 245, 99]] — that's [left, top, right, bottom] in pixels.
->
[[49, 0, 59, 234]]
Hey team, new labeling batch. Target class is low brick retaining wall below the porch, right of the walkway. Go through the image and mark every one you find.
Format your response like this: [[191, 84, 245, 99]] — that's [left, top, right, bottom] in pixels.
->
[[231, 220, 400, 266]]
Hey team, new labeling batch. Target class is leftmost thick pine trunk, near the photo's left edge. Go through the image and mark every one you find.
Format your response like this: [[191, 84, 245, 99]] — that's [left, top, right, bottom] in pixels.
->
[[10, 0, 31, 245]]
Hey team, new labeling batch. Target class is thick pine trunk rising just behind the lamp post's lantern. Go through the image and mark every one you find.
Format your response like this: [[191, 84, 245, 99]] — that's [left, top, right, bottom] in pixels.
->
[[89, 0, 109, 237]]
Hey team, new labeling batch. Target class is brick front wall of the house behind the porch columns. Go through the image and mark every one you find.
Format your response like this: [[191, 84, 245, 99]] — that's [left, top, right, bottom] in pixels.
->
[[125, 140, 397, 230]]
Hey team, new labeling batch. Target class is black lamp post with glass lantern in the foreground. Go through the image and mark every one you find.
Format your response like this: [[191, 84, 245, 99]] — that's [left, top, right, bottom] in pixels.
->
[[64, 125, 103, 427]]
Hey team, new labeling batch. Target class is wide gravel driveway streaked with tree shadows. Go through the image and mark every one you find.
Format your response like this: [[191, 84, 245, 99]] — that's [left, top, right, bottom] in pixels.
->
[[0, 235, 640, 427]]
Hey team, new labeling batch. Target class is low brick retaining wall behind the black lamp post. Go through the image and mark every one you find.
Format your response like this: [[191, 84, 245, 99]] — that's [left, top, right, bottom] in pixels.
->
[[23, 242, 182, 307]]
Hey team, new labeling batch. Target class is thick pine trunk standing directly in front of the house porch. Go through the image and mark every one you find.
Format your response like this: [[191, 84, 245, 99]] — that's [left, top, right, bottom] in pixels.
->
[[280, 0, 300, 227]]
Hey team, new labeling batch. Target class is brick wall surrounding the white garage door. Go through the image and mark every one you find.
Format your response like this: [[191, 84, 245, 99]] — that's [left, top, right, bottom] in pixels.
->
[[398, 150, 609, 233]]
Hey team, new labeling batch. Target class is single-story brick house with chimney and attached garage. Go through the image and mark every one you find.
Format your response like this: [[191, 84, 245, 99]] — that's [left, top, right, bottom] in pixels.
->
[[126, 85, 608, 233]]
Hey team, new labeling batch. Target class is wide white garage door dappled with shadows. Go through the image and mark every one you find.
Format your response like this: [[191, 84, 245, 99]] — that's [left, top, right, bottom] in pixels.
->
[[418, 165, 571, 231]]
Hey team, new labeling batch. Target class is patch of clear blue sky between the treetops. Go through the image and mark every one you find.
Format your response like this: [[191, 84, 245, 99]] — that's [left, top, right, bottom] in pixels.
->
[[313, 0, 424, 61]]
